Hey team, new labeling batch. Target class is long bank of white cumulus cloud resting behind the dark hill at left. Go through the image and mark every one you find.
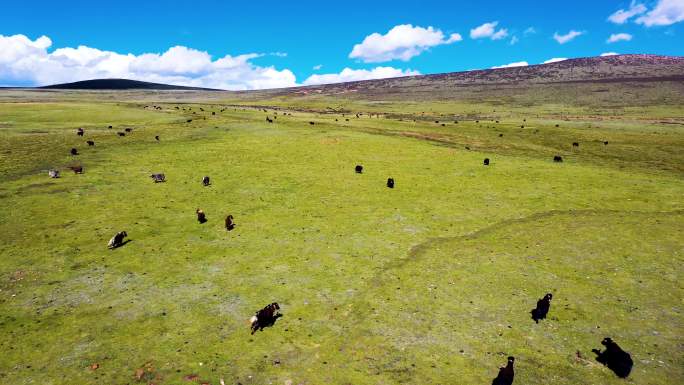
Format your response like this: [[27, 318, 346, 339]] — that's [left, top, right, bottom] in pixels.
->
[[0, 35, 297, 90]]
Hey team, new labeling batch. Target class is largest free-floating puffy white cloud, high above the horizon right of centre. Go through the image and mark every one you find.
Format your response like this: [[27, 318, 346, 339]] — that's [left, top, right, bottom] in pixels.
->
[[349, 24, 463, 63]]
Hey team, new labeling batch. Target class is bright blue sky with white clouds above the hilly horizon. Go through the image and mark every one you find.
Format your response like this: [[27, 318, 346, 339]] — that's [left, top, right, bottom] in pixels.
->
[[0, 0, 684, 89]]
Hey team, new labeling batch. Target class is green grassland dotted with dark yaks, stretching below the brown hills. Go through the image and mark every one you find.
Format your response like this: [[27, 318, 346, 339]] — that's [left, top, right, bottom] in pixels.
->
[[0, 84, 684, 385]]
